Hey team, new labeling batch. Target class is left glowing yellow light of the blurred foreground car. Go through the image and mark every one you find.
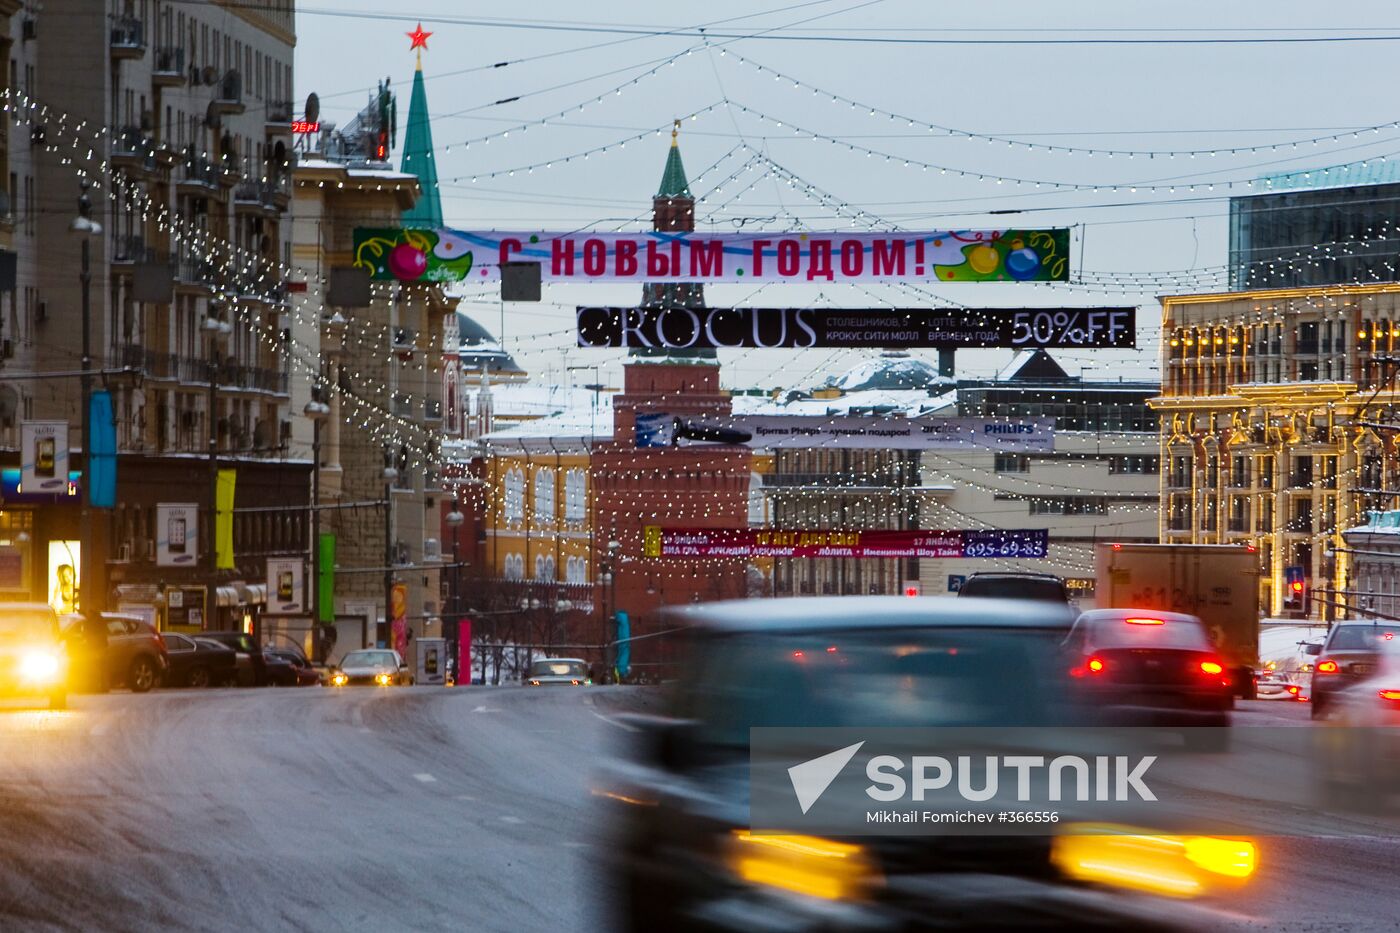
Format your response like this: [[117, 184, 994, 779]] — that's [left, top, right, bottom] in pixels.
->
[[729, 829, 881, 901]]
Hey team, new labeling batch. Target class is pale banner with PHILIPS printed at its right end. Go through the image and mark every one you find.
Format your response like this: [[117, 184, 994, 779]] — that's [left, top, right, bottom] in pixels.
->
[[637, 413, 1054, 452]]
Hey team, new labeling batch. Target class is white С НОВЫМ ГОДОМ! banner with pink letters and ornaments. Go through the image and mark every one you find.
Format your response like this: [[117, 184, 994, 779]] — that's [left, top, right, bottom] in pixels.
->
[[354, 227, 1070, 283]]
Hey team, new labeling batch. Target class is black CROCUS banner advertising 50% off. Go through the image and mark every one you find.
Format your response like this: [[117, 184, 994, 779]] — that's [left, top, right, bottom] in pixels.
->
[[577, 307, 1137, 350]]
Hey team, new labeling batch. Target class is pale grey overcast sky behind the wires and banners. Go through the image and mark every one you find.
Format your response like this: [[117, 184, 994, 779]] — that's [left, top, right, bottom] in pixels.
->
[[295, 0, 1400, 388]]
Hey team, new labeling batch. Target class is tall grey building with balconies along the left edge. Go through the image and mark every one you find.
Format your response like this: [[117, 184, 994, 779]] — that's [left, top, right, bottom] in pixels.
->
[[0, 0, 308, 623]]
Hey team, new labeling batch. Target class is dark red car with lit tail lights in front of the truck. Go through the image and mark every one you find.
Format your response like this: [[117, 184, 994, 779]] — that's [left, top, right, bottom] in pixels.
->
[[1064, 609, 1232, 747]]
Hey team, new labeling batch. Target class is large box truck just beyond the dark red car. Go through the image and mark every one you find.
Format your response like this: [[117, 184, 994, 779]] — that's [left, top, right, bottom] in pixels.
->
[[1093, 544, 1260, 699]]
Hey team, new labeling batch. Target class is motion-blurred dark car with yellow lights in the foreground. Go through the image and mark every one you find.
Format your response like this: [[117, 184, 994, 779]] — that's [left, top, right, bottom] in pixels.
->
[[595, 597, 1254, 933]]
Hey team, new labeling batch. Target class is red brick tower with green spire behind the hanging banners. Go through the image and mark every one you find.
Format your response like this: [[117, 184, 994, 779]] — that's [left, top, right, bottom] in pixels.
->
[[591, 120, 752, 672]]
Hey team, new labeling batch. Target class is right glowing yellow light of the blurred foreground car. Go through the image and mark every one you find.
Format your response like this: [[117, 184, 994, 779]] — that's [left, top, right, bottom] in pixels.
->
[[1050, 827, 1256, 898]]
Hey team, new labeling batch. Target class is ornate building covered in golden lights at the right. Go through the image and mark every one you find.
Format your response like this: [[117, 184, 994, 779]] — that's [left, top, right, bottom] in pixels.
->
[[1152, 284, 1400, 615]]
